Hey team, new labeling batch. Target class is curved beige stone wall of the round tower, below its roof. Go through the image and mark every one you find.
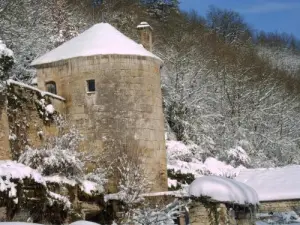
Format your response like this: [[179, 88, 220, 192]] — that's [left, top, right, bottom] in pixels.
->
[[37, 55, 167, 191]]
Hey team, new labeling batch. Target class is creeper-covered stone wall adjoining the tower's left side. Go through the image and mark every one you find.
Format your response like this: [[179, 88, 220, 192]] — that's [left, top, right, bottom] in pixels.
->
[[3, 81, 65, 160]]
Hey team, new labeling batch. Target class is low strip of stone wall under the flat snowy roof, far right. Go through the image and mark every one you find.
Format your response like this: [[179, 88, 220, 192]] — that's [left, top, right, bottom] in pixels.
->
[[258, 200, 300, 213]]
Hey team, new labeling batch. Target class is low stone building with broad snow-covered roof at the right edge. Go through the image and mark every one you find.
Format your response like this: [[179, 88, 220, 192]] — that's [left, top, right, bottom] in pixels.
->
[[235, 165, 300, 214]]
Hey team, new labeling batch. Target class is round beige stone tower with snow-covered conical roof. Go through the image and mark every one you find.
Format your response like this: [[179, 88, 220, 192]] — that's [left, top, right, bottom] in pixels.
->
[[32, 23, 167, 191]]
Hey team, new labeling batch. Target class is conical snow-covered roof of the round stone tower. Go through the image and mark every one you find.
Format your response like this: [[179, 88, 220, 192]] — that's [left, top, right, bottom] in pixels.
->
[[31, 23, 161, 66]]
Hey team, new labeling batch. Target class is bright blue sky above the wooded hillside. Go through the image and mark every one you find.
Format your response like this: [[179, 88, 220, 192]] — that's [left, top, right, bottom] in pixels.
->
[[180, 0, 300, 38]]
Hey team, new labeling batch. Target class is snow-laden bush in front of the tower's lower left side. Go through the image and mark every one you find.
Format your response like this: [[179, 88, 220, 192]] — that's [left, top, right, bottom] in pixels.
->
[[18, 119, 107, 193]]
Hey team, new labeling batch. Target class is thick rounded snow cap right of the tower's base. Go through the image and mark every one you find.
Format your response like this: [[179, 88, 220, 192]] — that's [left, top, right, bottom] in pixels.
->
[[189, 176, 259, 205]]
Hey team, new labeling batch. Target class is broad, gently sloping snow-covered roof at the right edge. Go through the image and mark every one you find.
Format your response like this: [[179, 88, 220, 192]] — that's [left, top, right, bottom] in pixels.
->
[[235, 165, 300, 201]]
